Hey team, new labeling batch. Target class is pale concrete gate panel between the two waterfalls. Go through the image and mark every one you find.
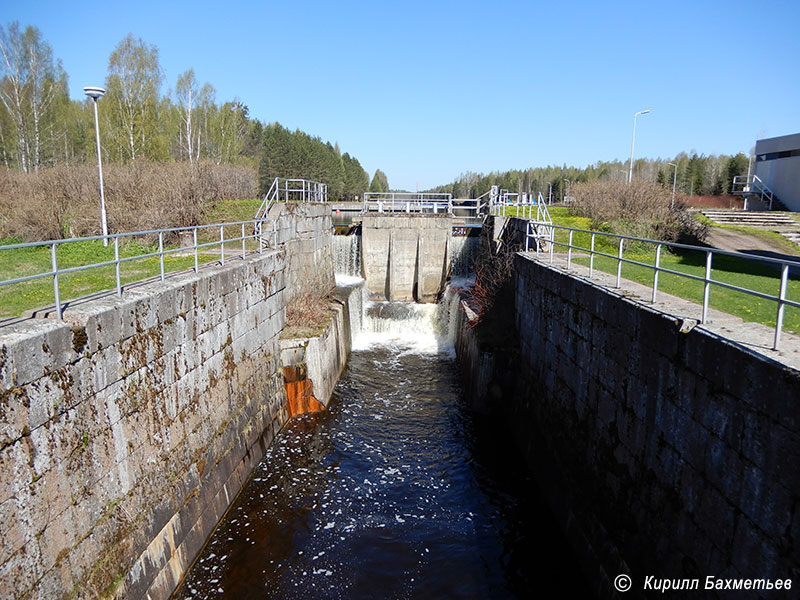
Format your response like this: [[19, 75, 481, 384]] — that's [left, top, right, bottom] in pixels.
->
[[361, 214, 453, 302]]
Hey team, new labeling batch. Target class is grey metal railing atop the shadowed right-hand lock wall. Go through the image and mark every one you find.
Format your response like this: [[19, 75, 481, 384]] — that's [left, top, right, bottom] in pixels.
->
[[525, 221, 800, 350]]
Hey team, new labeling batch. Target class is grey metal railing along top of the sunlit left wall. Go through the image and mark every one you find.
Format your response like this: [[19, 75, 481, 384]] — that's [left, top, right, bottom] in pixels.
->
[[0, 219, 277, 319]]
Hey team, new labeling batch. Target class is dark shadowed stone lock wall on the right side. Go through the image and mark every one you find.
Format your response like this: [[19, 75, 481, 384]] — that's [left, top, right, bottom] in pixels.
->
[[504, 254, 800, 595]]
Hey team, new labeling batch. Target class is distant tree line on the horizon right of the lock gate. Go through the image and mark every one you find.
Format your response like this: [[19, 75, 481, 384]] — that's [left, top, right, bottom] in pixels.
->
[[430, 152, 748, 202]]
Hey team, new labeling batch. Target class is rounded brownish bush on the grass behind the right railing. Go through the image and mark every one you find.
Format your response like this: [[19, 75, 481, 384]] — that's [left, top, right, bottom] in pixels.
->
[[570, 181, 705, 241]]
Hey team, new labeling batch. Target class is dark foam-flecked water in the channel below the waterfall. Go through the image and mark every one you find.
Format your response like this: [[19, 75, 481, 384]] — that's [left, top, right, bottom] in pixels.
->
[[177, 346, 589, 599]]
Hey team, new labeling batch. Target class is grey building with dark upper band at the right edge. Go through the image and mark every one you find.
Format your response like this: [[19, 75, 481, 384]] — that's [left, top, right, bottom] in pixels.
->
[[755, 133, 800, 211]]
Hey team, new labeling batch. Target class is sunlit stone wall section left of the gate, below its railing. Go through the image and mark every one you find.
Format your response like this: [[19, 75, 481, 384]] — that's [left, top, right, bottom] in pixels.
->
[[265, 202, 336, 301]]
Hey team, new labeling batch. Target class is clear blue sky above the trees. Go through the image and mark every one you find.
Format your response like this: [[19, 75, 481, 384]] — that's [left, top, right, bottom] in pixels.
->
[[0, 0, 800, 190]]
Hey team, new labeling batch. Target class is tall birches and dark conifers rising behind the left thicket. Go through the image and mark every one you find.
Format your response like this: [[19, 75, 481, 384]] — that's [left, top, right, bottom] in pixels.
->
[[0, 22, 384, 200]]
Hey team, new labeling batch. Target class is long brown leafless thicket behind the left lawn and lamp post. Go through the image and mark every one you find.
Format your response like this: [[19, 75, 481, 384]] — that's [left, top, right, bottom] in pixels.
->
[[0, 161, 256, 241]]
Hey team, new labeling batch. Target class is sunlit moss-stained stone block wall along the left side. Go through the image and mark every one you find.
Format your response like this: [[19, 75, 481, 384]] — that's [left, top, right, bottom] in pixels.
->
[[0, 252, 288, 598]]
